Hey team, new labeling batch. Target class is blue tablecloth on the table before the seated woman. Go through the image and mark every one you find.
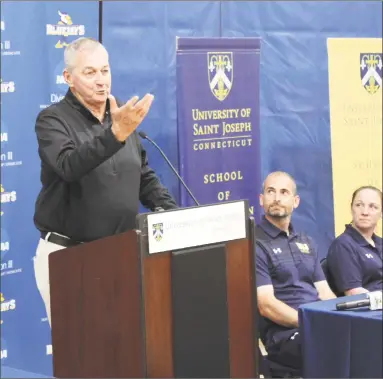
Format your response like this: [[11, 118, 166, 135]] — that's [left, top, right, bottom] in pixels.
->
[[299, 295, 383, 378]]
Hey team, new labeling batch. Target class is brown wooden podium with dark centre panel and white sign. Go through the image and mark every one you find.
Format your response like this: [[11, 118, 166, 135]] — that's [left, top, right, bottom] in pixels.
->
[[49, 201, 258, 378]]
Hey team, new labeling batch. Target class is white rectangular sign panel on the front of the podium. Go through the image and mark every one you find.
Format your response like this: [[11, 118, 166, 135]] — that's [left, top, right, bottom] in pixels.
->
[[147, 200, 246, 254]]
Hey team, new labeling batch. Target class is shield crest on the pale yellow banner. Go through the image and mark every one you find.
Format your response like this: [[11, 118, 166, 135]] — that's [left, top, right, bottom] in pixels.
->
[[360, 53, 383, 95]]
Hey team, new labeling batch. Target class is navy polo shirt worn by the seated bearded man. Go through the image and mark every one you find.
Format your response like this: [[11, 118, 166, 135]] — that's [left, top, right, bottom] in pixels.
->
[[255, 216, 326, 340]]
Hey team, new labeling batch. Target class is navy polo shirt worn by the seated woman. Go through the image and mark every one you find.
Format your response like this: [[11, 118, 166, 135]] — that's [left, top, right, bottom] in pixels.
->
[[327, 225, 383, 293]]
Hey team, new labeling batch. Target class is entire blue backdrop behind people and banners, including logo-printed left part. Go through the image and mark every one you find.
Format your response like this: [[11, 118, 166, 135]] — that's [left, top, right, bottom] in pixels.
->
[[1, 1, 382, 375]]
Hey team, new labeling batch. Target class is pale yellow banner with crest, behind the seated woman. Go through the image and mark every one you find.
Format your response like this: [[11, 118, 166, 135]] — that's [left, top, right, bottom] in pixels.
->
[[327, 38, 382, 236]]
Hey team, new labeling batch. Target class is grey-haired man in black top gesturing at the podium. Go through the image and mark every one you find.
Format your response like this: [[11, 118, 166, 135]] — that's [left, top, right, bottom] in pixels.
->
[[34, 38, 177, 323]]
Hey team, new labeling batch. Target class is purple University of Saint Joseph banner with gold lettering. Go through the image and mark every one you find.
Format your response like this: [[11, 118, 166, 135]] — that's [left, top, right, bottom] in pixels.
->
[[177, 38, 261, 220]]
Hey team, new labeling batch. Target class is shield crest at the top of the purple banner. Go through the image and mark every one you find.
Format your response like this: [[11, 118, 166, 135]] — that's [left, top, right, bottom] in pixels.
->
[[207, 52, 233, 101]]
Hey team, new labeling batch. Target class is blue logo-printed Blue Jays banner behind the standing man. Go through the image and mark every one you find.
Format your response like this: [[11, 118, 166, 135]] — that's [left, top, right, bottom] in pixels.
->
[[0, 1, 98, 376]]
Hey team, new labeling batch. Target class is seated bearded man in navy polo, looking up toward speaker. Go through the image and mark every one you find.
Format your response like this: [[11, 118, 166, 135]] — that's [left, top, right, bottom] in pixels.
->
[[256, 171, 335, 374]]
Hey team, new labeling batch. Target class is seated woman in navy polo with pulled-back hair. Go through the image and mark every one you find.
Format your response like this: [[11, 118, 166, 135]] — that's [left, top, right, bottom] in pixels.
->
[[327, 186, 383, 295]]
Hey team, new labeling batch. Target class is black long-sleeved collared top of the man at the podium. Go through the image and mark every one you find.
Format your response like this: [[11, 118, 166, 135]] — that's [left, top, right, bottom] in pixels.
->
[[34, 90, 177, 242]]
